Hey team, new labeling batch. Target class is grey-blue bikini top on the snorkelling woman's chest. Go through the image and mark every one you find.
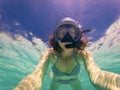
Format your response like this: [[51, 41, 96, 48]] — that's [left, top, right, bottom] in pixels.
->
[[52, 53, 80, 76]]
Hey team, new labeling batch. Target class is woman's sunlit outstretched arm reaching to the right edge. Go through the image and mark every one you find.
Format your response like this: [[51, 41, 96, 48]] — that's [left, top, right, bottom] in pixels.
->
[[81, 50, 120, 90]]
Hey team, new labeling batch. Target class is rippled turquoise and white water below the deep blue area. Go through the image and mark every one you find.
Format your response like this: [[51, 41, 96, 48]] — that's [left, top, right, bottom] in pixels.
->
[[0, 19, 120, 90]]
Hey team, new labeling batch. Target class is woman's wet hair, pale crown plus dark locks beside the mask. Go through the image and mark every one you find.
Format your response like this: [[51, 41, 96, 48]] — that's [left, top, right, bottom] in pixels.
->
[[49, 17, 88, 53]]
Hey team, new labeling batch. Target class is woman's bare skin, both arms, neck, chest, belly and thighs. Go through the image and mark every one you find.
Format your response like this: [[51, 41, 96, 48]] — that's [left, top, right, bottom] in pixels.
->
[[14, 43, 120, 90]]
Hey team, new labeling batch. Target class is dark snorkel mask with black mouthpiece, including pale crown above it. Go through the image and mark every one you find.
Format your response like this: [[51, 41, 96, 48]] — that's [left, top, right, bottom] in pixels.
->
[[54, 17, 82, 48]]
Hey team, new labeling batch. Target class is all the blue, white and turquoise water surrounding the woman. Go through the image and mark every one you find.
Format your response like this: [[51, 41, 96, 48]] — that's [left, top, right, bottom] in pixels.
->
[[0, 0, 120, 90]]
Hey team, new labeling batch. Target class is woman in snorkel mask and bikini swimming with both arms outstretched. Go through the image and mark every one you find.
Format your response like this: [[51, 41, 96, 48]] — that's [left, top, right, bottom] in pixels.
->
[[14, 17, 120, 90]]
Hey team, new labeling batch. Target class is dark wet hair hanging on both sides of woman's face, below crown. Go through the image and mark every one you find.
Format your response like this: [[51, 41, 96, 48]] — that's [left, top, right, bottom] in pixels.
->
[[49, 33, 88, 53]]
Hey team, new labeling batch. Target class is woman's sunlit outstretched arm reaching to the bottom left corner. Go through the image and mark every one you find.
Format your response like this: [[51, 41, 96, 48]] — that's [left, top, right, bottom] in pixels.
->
[[14, 50, 50, 90]]
